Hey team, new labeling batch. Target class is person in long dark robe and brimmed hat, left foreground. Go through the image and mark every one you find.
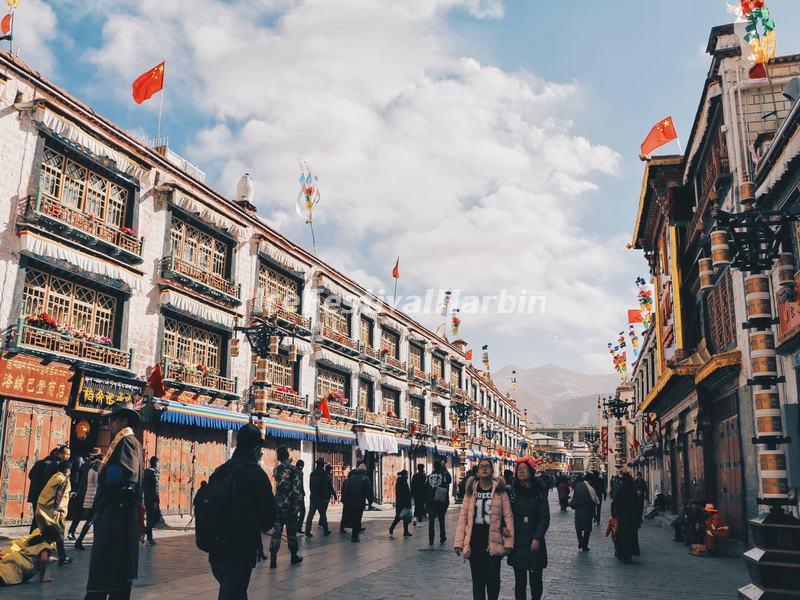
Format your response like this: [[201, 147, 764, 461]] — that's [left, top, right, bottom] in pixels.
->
[[86, 402, 144, 600]]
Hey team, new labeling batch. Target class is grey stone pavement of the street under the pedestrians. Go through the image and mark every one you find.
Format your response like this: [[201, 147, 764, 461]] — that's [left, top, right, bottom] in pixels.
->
[[0, 492, 748, 600]]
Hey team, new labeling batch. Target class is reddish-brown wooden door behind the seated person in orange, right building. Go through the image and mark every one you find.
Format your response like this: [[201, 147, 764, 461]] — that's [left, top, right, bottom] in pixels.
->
[[713, 404, 746, 540]]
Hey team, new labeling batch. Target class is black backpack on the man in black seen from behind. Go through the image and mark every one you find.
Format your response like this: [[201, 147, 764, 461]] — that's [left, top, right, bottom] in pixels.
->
[[194, 463, 250, 554]]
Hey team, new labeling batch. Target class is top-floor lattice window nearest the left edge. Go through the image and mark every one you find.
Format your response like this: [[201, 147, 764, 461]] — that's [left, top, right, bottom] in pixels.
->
[[39, 146, 128, 229]]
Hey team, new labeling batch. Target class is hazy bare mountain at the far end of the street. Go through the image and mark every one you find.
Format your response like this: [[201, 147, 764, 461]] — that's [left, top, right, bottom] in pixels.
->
[[492, 365, 619, 425]]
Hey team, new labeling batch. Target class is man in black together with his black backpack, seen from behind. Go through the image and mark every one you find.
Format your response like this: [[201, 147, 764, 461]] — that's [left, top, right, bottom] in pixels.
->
[[195, 424, 275, 600]]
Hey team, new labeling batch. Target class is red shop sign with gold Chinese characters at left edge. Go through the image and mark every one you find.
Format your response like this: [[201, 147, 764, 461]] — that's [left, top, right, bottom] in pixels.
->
[[0, 354, 75, 406]]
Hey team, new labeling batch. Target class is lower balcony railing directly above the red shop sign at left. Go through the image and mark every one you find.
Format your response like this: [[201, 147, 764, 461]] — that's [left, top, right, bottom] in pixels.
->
[[13, 319, 133, 371]]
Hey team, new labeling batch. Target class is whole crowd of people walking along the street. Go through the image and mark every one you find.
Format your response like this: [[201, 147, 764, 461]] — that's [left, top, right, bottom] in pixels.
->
[[0, 418, 729, 600]]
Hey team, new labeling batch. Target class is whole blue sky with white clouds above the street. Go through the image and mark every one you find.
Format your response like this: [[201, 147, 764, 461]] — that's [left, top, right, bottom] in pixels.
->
[[9, 0, 800, 373]]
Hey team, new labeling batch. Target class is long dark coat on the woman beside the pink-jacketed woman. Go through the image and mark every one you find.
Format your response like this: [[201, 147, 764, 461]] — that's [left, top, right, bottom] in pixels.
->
[[508, 479, 550, 571]]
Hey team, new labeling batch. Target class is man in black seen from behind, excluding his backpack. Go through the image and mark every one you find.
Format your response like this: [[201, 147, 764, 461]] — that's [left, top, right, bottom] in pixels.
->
[[206, 423, 275, 598]]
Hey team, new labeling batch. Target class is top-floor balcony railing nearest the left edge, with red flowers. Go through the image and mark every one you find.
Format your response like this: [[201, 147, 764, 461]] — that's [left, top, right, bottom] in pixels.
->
[[26, 192, 143, 262]]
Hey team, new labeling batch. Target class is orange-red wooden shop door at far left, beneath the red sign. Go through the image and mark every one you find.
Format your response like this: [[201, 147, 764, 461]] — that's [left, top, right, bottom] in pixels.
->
[[0, 400, 70, 525]]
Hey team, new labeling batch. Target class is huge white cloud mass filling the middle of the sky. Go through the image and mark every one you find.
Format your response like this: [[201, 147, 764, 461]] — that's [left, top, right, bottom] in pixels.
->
[[54, 0, 627, 366]]
